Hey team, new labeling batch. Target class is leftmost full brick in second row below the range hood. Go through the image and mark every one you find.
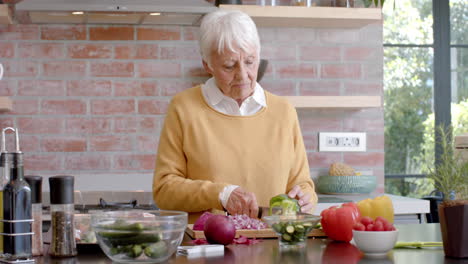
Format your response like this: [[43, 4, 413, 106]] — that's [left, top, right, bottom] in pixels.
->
[[18, 43, 65, 59]]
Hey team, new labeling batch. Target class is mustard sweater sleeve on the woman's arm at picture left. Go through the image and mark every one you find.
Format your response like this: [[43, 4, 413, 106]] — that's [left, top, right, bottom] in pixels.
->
[[153, 98, 228, 212]]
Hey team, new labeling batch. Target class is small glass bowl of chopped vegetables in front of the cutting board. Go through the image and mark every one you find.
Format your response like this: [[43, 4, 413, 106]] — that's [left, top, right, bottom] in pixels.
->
[[262, 214, 320, 248]]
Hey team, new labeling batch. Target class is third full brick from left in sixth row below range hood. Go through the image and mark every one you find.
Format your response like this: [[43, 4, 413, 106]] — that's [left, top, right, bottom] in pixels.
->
[[114, 116, 160, 133]]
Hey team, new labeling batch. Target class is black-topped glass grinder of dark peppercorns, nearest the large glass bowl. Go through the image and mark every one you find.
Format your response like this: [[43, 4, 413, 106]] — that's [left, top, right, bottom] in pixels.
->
[[49, 176, 77, 257]]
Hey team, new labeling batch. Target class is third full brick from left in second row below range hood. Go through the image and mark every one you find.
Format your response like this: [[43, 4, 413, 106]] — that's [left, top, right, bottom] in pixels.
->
[[114, 44, 159, 60]]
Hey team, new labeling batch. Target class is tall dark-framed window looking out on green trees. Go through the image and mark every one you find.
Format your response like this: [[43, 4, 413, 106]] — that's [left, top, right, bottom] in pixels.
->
[[383, 0, 468, 197]]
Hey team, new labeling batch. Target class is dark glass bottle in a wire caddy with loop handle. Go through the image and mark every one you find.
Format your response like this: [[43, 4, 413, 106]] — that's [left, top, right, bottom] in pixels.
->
[[1, 127, 33, 260]]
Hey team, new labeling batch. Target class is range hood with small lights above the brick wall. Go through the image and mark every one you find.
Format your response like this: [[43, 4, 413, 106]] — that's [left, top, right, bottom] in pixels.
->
[[16, 0, 217, 25]]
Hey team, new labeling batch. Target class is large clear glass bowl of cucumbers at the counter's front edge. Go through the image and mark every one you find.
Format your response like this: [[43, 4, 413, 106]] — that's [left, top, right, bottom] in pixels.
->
[[91, 210, 187, 263]]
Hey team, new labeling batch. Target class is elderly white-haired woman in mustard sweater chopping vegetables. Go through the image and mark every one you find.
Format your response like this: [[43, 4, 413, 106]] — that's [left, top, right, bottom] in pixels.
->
[[153, 8, 317, 222]]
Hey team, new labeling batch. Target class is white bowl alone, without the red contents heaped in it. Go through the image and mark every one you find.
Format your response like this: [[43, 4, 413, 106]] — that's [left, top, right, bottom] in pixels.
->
[[353, 230, 398, 256]]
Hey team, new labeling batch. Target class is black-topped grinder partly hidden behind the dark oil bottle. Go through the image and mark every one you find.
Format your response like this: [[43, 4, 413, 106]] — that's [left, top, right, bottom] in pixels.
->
[[25, 176, 43, 256]]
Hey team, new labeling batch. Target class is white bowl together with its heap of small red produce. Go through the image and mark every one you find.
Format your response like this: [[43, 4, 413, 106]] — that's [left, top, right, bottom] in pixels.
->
[[353, 217, 398, 257]]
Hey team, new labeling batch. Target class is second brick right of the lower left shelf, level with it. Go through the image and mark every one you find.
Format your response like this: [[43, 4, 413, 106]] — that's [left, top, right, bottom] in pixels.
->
[[41, 100, 86, 115]]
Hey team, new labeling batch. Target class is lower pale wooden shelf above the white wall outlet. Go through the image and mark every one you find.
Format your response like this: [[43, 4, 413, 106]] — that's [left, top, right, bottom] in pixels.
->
[[286, 96, 382, 108]]
